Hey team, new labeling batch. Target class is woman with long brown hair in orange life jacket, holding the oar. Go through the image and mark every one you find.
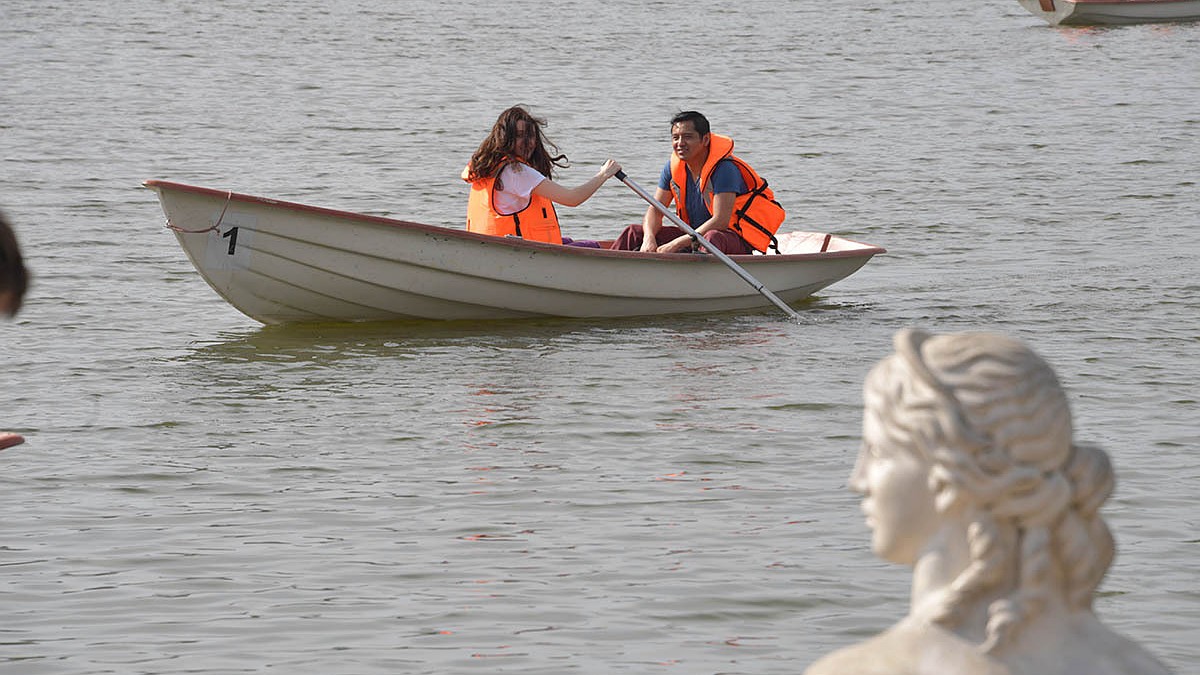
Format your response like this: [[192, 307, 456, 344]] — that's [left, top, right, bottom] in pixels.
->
[[462, 106, 620, 245]]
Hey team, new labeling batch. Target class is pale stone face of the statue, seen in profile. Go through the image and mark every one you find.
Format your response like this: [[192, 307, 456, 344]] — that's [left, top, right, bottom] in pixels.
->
[[850, 401, 938, 565]]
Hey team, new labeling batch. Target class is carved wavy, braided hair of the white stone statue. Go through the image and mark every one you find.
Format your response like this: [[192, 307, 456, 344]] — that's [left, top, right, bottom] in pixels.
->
[[864, 330, 1114, 653]]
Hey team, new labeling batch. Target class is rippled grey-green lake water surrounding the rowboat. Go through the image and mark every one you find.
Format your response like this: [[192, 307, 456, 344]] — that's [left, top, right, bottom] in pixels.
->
[[0, 0, 1200, 675]]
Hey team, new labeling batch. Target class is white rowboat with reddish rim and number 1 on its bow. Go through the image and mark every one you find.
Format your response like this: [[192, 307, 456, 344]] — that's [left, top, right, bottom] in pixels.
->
[[145, 180, 884, 323]]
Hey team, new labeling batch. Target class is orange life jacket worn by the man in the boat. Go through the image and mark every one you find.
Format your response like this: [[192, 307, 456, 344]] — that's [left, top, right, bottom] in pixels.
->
[[671, 133, 787, 253]]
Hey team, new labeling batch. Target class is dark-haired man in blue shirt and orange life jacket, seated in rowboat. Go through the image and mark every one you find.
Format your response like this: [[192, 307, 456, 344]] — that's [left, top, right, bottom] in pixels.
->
[[612, 110, 751, 255]]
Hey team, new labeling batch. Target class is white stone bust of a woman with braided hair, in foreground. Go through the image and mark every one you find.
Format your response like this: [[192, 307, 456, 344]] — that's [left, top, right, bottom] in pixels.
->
[[808, 330, 1166, 675]]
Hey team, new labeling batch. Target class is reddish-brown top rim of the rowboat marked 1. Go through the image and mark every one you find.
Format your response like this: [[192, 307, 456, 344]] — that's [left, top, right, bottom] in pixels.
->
[[143, 179, 887, 264]]
